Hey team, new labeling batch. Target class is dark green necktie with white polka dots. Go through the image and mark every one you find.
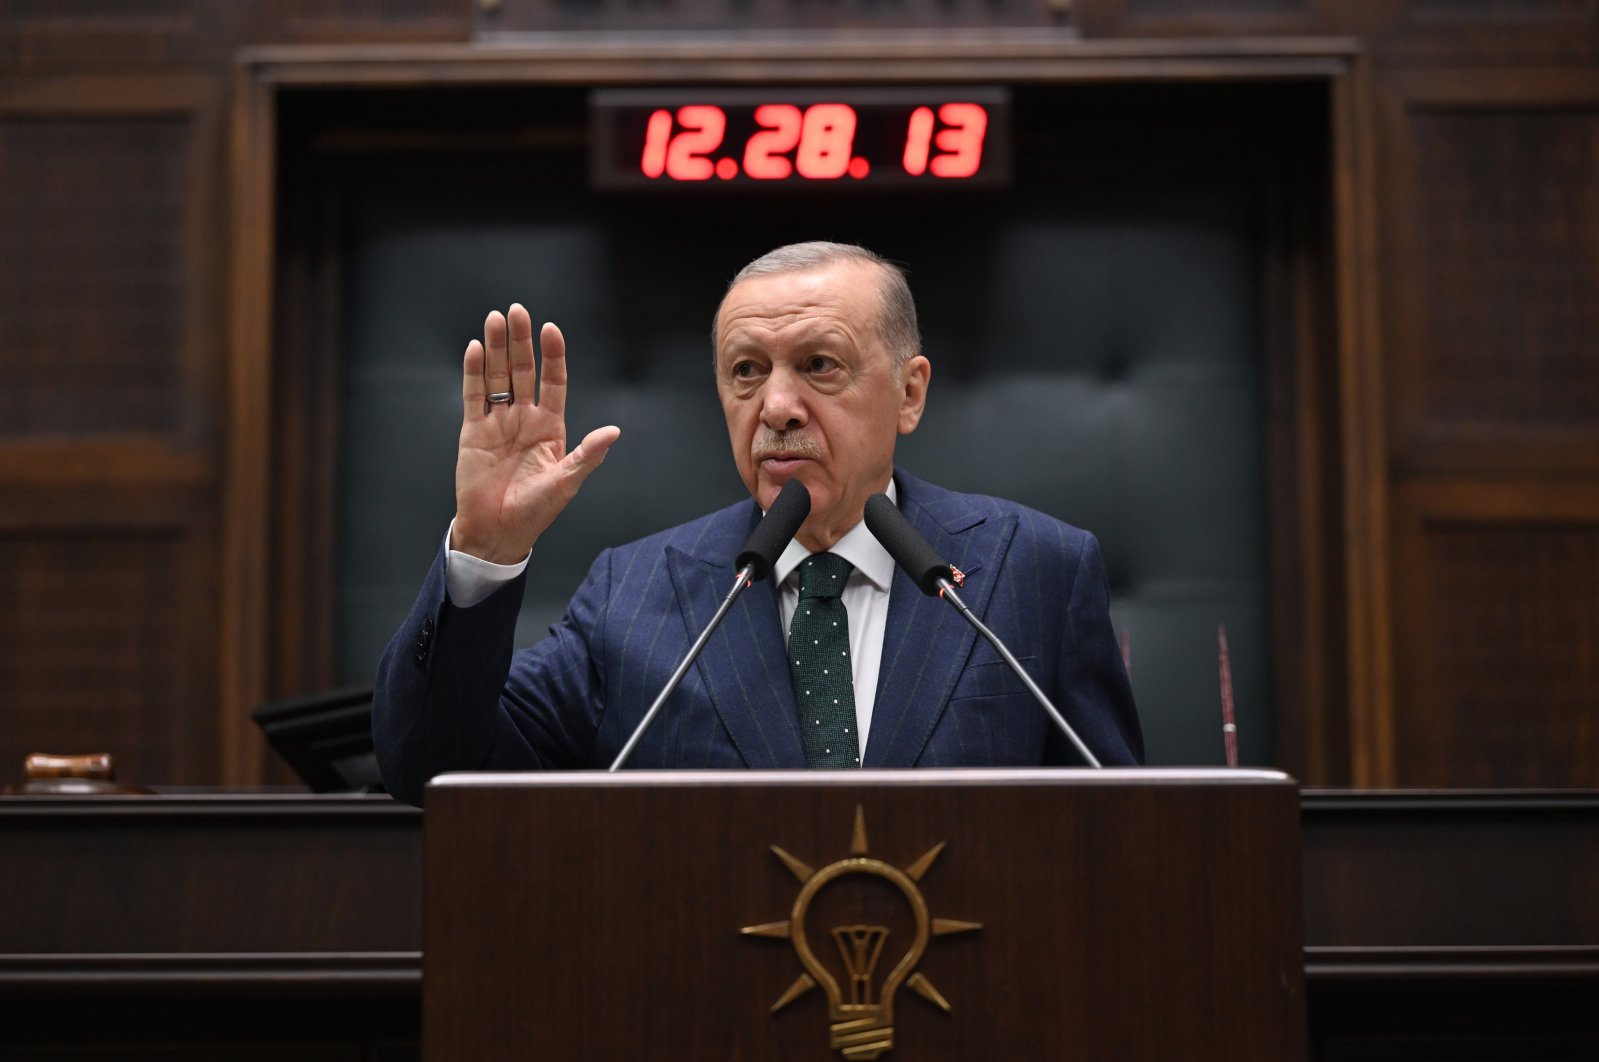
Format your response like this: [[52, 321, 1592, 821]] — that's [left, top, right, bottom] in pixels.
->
[[788, 553, 860, 768]]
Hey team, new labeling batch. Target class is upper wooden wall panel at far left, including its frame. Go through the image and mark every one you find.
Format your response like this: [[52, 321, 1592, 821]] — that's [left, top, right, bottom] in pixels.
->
[[0, 75, 224, 449]]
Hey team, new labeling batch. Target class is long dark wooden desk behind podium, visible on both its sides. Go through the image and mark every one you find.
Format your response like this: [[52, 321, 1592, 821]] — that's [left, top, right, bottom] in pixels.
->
[[0, 792, 1599, 1062]]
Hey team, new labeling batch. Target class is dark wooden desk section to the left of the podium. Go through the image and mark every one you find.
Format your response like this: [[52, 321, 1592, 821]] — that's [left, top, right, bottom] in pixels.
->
[[0, 792, 422, 1062]]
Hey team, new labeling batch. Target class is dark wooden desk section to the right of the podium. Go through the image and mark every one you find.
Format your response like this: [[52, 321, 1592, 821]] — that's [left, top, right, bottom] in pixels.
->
[[1300, 790, 1599, 1062]]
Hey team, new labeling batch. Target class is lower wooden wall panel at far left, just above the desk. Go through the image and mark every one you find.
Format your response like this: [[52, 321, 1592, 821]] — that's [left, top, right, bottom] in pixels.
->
[[0, 485, 219, 785]]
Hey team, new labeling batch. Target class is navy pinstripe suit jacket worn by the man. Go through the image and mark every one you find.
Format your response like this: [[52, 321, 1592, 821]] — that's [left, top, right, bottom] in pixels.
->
[[373, 470, 1143, 803]]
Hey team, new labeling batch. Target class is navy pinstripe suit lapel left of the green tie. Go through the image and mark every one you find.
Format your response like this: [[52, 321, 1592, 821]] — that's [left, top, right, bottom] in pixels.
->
[[667, 505, 804, 768]]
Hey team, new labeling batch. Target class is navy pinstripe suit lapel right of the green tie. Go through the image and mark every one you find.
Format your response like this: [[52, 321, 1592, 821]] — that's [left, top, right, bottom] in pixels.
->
[[865, 472, 1015, 768]]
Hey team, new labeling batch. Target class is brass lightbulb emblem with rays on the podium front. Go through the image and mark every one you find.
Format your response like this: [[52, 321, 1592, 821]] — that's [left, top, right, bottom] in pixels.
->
[[740, 806, 982, 1062]]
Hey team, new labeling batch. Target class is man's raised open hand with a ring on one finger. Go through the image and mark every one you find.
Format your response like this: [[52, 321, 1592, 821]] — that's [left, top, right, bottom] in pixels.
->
[[449, 304, 622, 565]]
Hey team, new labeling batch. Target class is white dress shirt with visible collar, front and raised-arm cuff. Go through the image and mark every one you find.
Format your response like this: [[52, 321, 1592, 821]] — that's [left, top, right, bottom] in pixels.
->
[[445, 478, 899, 761]]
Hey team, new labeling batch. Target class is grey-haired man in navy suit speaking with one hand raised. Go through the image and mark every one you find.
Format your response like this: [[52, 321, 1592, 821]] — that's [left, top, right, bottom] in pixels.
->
[[373, 243, 1143, 803]]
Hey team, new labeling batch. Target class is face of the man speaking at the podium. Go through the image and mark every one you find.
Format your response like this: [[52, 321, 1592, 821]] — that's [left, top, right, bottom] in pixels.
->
[[716, 262, 931, 550]]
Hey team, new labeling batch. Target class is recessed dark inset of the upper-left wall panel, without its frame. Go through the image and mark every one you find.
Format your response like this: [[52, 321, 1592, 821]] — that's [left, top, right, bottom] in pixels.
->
[[0, 110, 191, 438]]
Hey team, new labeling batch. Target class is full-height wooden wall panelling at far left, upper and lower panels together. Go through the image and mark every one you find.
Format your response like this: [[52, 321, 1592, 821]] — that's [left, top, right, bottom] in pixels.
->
[[0, 74, 222, 784]]
